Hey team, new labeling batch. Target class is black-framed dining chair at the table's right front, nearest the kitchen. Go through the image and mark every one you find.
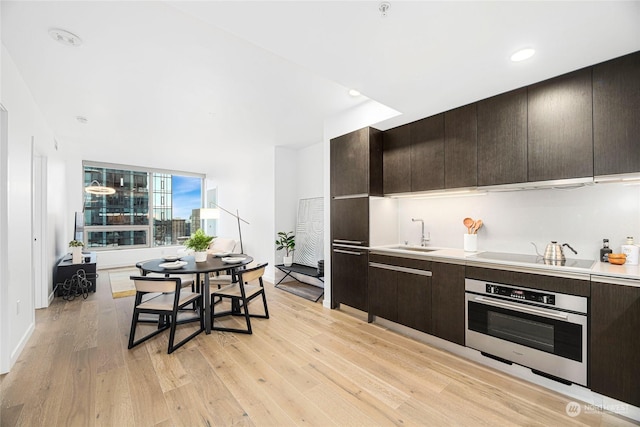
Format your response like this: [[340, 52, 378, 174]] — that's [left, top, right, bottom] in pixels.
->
[[211, 263, 269, 334]]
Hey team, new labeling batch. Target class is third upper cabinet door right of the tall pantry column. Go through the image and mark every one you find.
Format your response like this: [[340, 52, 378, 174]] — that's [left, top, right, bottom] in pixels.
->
[[444, 104, 478, 188]]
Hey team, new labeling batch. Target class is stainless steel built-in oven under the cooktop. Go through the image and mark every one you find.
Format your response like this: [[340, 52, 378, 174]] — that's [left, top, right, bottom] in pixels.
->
[[465, 279, 587, 386]]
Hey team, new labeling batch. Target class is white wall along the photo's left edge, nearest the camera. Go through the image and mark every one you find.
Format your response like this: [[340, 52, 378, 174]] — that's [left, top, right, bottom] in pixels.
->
[[0, 42, 64, 371]]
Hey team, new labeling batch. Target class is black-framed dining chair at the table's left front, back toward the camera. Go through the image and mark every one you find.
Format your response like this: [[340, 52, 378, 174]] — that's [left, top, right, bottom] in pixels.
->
[[129, 276, 204, 354]]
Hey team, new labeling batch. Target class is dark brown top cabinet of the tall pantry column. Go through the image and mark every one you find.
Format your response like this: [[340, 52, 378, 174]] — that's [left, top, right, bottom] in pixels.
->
[[330, 127, 382, 197]]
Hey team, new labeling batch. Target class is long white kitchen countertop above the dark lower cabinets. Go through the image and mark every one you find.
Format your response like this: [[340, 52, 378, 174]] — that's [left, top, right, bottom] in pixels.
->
[[369, 245, 640, 287]]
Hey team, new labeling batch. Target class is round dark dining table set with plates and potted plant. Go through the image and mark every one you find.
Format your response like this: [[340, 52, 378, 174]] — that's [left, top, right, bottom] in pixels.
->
[[139, 254, 253, 334]]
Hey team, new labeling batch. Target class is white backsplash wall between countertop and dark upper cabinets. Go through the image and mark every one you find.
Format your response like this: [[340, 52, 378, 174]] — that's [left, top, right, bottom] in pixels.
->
[[398, 184, 640, 259]]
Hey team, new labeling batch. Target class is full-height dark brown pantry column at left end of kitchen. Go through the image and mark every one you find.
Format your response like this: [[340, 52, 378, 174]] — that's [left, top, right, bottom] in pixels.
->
[[330, 127, 382, 311]]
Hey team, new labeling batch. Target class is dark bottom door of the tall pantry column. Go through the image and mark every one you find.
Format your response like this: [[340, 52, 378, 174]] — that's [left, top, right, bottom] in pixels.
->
[[331, 248, 369, 311]]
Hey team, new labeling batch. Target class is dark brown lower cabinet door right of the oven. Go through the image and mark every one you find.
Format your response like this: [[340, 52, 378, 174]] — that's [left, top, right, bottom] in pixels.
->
[[589, 282, 640, 406]]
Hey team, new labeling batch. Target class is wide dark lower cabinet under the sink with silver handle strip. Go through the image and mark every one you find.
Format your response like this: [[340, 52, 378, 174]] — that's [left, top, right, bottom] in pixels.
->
[[369, 255, 432, 334]]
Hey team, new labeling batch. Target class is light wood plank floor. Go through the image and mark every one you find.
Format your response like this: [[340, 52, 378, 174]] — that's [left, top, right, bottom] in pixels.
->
[[0, 271, 631, 426]]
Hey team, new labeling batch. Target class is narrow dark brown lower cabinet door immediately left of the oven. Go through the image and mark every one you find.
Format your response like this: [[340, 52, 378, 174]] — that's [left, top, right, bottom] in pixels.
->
[[431, 262, 465, 345]]
